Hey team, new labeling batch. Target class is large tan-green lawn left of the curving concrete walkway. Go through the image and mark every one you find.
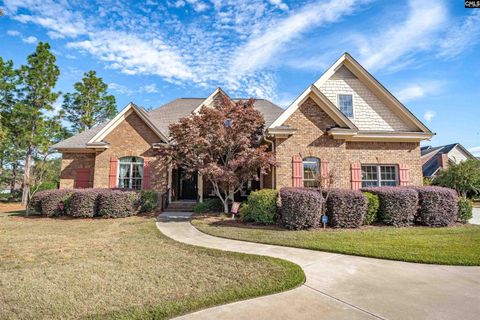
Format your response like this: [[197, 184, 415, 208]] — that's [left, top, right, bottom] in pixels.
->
[[0, 204, 304, 319]]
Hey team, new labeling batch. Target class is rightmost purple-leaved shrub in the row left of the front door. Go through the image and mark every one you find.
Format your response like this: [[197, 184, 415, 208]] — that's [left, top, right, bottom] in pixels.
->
[[98, 190, 140, 218]]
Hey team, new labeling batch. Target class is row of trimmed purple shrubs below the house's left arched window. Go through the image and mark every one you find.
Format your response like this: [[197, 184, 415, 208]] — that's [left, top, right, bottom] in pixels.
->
[[29, 189, 159, 218]]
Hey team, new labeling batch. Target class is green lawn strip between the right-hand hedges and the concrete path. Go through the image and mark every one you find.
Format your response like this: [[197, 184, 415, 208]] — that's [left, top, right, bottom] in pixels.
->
[[192, 217, 480, 266]]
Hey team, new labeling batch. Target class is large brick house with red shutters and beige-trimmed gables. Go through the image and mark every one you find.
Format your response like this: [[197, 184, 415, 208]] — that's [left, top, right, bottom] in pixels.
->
[[54, 53, 433, 201]]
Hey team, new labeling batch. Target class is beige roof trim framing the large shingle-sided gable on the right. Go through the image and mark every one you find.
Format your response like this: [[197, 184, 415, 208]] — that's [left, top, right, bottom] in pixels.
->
[[269, 53, 433, 140]]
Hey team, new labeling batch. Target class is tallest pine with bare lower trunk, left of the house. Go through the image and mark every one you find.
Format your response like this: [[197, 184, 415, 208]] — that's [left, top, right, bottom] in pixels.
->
[[12, 42, 62, 205]]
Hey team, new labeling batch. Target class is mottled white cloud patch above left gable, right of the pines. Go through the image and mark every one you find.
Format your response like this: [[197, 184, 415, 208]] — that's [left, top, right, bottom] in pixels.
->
[[67, 31, 193, 80]]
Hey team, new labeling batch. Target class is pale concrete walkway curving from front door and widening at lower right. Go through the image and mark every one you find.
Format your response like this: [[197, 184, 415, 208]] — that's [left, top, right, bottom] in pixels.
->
[[157, 213, 480, 320]]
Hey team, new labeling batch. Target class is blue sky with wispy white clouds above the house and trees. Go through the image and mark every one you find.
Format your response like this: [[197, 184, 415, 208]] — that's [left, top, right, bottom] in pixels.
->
[[0, 0, 480, 156]]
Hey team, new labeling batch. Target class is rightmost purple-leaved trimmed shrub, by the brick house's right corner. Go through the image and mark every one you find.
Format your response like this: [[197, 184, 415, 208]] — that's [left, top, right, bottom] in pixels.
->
[[413, 186, 458, 227]]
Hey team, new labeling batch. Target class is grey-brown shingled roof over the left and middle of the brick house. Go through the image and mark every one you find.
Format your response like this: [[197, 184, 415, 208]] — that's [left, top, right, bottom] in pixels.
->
[[52, 98, 283, 152]]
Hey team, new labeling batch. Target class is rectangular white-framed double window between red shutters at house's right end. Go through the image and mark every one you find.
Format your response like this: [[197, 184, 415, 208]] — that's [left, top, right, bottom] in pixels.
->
[[362, 165, 398, 188]]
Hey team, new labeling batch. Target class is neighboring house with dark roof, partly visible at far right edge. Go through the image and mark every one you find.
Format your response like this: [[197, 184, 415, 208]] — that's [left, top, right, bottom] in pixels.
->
[[421, 143, 475, 178]]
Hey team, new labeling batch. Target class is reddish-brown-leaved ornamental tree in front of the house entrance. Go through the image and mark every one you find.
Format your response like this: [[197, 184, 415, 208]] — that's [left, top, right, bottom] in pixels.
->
[[160, 97, 274, 213]]
